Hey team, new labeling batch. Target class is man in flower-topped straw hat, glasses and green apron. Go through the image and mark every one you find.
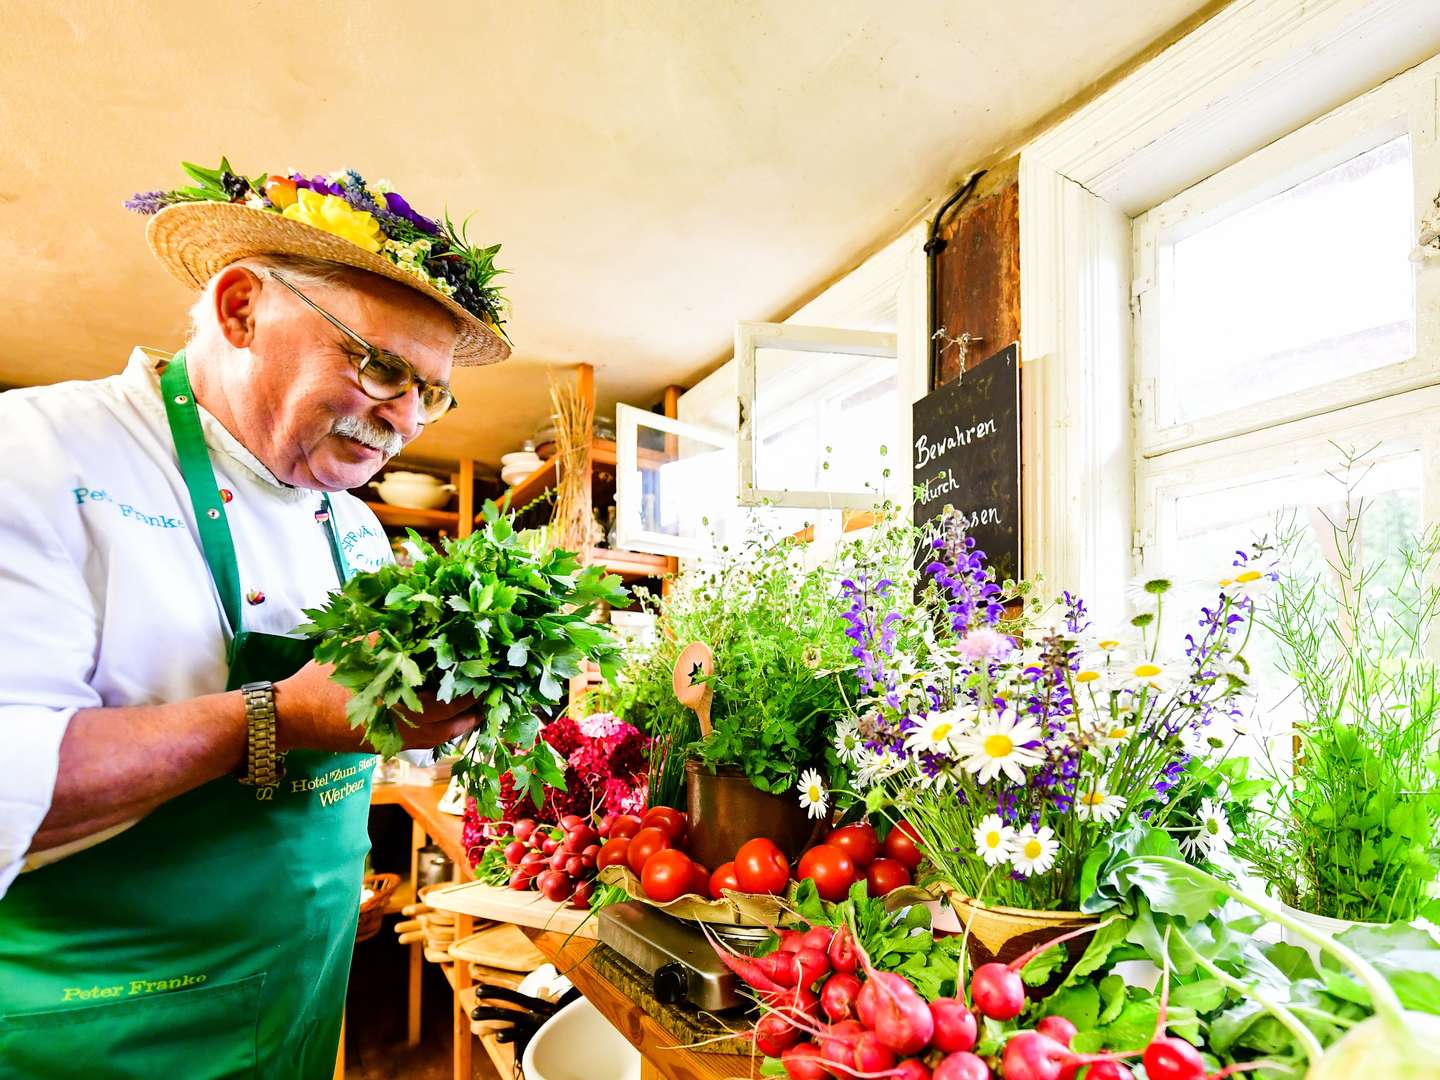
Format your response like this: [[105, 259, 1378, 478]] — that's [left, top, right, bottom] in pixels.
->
[[0, 163, 508, 1080]]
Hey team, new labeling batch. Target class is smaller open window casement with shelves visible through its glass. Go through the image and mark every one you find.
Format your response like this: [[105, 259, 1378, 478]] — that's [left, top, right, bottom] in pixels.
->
[[615, 405, 734, 557]]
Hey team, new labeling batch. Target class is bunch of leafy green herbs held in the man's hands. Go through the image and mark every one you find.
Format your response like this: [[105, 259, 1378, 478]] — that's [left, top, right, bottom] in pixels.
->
[[300, 503, 625, 816]]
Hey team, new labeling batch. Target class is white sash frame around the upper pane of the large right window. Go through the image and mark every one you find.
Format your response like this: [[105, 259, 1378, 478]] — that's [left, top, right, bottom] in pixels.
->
[[1132, 58, 1440, 458]]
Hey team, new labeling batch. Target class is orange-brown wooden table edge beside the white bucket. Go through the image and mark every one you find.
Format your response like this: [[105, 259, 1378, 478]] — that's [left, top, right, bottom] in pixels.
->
[[526, 929, 760, 1080]]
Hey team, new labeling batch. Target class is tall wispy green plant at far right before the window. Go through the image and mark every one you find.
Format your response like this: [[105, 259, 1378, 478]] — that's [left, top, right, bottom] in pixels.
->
[[1236, 454, 1440, 923]]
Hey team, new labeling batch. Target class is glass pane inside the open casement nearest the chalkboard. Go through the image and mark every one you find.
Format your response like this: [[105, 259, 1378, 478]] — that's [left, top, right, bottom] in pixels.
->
[[755, 347, 900, 495]]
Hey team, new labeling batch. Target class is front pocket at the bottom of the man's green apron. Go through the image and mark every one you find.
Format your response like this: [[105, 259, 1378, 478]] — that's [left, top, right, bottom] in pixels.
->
[[0, 973, 265, 1080]]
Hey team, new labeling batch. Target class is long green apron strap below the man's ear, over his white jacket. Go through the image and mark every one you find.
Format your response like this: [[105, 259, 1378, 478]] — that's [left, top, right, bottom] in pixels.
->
[[160, 350, 242, 638]]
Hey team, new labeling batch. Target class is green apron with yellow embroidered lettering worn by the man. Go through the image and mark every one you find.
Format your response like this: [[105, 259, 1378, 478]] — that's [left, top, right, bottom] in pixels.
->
[[0, 353, 374, 1080]]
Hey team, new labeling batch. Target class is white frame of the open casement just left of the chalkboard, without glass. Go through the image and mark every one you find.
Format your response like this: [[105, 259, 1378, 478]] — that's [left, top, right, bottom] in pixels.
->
[[734, 323, 909, 510]]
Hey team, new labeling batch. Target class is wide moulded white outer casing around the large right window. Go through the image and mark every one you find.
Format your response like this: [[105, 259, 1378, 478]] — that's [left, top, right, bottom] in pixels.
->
[[1020, 0, 1440, 615]]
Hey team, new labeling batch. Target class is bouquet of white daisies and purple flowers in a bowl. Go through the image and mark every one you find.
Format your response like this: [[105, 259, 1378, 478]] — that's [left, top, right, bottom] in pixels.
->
[[835, 516, 1270, 910]]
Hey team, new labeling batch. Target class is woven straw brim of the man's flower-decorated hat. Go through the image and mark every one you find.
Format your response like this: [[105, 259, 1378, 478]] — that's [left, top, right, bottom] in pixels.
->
[[145, 202, 510, 366]]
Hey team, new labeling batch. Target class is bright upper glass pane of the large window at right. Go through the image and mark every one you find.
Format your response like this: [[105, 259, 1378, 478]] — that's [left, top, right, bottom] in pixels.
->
[[1162, 135, 1416, 423]]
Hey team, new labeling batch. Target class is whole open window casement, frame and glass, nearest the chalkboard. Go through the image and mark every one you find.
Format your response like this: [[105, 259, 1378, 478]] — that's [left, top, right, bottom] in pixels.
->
[[734, 323, 892, 510]]
